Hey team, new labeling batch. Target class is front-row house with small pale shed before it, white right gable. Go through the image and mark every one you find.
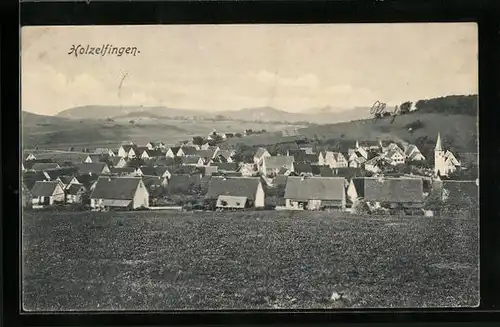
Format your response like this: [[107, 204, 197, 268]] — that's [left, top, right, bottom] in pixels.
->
[[206, 177, 265, 208]]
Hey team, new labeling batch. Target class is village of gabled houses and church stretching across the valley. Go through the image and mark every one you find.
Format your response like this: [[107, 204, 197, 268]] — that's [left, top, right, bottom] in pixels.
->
[[22, 131, 479, 217]]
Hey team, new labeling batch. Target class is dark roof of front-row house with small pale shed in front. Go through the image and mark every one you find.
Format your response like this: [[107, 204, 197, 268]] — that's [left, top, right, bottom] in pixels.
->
[[207, 177, 260, 200]]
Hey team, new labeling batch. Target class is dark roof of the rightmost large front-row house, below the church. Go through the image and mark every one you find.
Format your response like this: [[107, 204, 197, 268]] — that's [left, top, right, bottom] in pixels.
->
[[352, 177, 423, 203]]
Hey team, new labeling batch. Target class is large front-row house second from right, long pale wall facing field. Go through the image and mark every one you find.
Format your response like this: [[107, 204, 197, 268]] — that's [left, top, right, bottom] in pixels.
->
[[285, 176, 346, 210]]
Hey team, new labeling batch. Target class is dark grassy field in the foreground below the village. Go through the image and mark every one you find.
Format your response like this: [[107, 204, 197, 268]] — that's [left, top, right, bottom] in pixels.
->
[[22, 211, 479, 311]]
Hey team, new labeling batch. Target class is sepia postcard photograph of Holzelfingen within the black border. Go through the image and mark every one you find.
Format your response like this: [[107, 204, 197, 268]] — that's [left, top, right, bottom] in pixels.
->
[[19, 23, 480, 312]]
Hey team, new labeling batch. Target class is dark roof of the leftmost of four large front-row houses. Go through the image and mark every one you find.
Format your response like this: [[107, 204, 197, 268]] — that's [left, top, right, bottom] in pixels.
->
[[91, 177, 141, 200]]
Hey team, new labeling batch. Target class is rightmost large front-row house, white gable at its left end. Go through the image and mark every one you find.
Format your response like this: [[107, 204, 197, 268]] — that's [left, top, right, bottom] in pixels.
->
[[347, 177, 424, 209]]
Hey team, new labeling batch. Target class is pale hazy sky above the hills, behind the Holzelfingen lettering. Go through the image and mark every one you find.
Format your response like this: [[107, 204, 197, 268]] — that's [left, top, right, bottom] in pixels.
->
[[21, 23, 478, 114]]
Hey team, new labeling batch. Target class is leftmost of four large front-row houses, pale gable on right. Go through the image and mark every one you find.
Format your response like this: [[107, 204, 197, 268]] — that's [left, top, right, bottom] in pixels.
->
[[90, 177, 149, 209]]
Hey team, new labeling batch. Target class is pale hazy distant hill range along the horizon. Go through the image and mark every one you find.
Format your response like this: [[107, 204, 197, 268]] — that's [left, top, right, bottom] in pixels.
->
[[56, 105, 369, 124]]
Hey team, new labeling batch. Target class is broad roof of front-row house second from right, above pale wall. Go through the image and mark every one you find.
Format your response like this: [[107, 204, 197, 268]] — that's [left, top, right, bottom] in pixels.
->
[[285, 177, 345, 200]]
